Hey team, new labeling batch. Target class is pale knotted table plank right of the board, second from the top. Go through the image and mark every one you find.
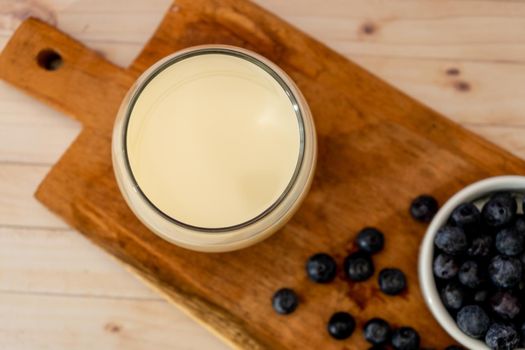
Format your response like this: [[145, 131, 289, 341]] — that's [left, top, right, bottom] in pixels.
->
[[351, 55, 525, 126]]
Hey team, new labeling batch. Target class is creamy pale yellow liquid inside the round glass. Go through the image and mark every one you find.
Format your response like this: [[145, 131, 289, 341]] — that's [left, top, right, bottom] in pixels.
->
[[125, 53, 301, 228]]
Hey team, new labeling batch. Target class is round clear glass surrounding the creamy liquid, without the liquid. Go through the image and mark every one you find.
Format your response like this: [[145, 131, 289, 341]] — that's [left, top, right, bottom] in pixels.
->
[[112, 45, 317, 252]]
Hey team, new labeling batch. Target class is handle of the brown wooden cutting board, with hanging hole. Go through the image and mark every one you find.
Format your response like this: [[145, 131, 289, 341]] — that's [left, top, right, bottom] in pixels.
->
[[0, 18, 132, 127]]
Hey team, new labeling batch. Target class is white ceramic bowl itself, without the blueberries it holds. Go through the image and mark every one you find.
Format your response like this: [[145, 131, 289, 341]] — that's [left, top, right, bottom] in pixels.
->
[[419, 176, 525, 349]]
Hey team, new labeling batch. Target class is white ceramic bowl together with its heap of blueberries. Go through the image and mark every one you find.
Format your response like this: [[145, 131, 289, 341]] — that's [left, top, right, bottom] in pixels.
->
[[419, 176, 525, 350]]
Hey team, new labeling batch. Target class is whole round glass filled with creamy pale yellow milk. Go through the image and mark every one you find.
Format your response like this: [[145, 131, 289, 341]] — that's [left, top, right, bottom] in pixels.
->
[[112, 45, 317, 252]]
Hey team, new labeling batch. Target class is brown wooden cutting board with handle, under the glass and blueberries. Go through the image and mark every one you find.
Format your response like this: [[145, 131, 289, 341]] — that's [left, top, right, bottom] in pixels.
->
[[0, 0, 525, 349]]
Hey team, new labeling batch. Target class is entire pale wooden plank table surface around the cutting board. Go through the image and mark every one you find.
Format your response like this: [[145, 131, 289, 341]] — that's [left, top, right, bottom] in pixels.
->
[[0, 0, 525, 350]]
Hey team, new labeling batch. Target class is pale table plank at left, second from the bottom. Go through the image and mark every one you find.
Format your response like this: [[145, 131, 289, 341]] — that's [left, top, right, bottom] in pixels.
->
[[0, 227, 161, 300]]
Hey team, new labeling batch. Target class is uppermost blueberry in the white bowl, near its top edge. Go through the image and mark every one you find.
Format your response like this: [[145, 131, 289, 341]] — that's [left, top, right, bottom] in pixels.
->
[[481, 192, 518, 228]]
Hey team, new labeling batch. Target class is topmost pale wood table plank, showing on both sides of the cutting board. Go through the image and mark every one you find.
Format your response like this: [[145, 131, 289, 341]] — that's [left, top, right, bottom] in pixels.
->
[[4, 0, 525, 62]]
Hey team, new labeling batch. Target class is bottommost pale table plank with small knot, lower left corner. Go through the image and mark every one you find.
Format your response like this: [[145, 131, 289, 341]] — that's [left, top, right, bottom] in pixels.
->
[[0, 293, 226, 350]]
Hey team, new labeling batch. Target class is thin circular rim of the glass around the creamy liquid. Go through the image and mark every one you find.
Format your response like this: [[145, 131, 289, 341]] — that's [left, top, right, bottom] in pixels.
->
[[121, 46, 306, 233]]
